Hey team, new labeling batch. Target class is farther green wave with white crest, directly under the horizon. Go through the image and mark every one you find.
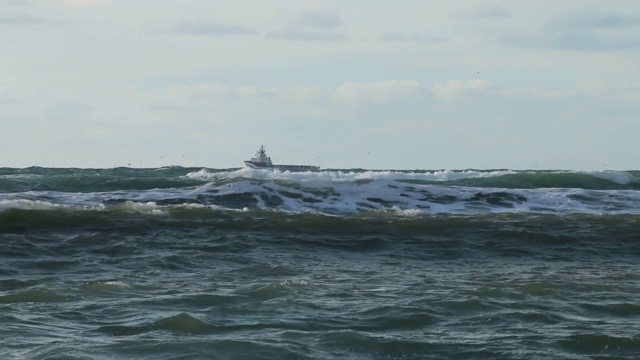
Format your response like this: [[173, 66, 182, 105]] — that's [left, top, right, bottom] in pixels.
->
[[0, 167, 640, 193]]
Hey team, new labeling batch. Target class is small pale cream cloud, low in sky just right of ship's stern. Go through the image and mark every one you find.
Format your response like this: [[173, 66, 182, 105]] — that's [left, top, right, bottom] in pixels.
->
[[336, 80, 420, 104]]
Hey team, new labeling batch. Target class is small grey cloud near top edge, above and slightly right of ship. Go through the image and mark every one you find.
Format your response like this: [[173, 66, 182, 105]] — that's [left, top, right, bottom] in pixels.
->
[[266, 10, 348, 41]]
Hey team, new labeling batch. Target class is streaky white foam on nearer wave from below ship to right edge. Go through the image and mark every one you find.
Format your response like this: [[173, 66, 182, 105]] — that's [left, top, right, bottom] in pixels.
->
[[248, 180, 640, 216]]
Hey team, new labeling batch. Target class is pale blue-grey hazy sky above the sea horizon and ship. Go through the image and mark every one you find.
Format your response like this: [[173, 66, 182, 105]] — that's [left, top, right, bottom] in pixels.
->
[[0, 0, 640, 171]]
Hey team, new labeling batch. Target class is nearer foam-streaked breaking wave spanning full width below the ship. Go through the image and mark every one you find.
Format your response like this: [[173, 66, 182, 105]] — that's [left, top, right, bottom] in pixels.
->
[[0, 180, 640, 216]]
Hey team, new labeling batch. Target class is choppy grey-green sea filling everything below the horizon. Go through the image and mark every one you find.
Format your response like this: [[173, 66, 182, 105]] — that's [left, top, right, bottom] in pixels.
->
[[0, 167, 640, 360]]
